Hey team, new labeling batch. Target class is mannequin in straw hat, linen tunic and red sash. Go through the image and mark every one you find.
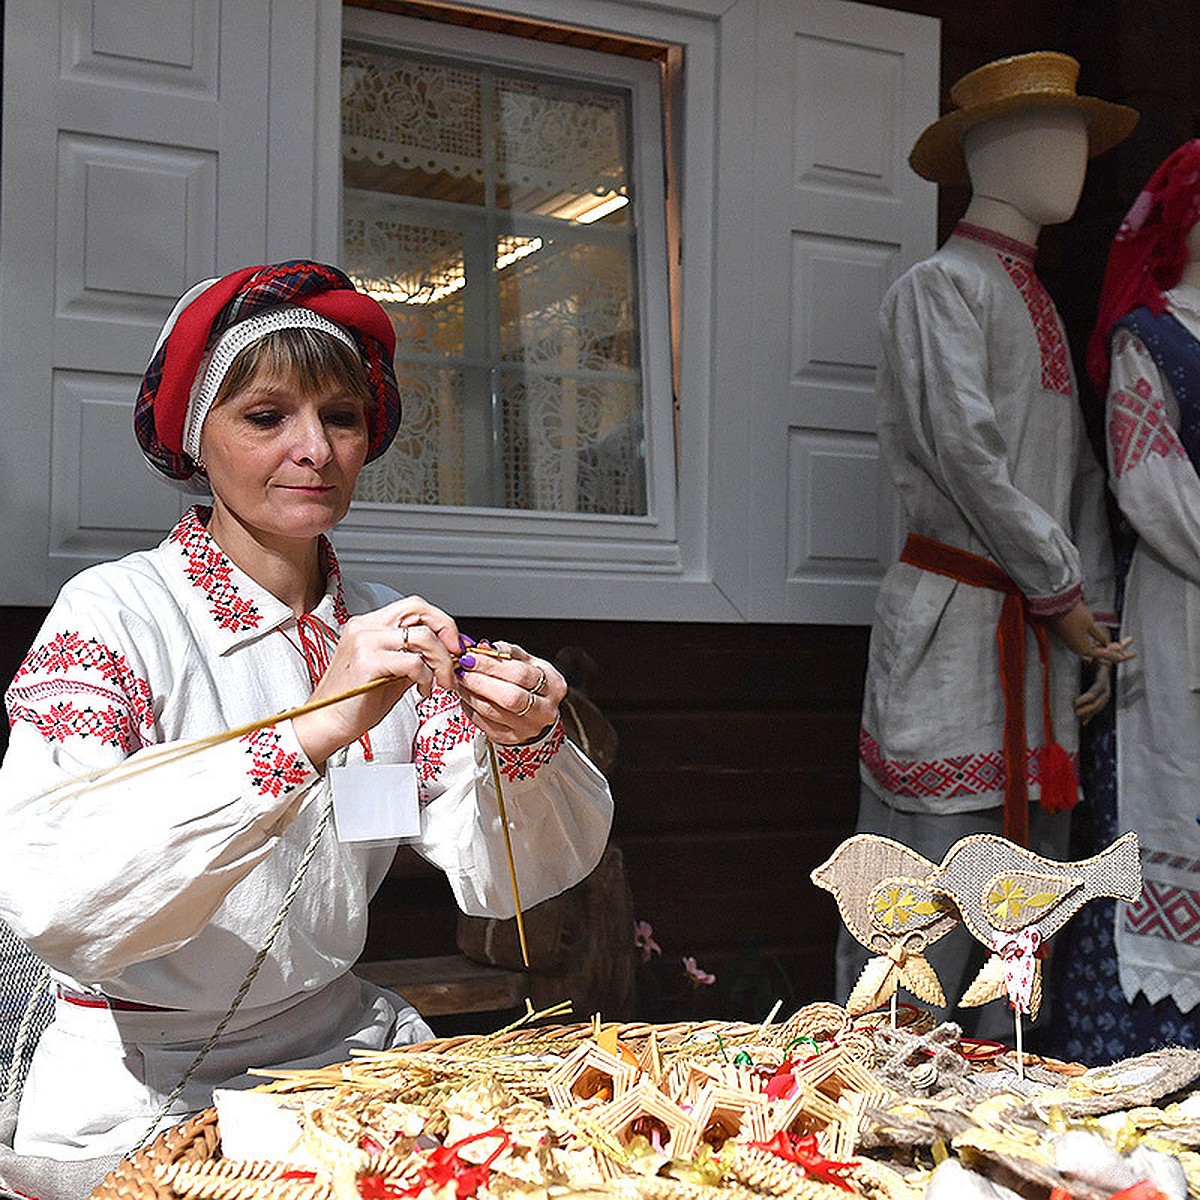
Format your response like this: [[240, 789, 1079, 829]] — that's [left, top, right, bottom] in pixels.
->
[[838, 53, 1136, 1036]]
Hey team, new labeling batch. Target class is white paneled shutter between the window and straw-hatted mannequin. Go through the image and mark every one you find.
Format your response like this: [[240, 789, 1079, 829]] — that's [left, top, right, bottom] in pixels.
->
[[746, 0, 938, 624]]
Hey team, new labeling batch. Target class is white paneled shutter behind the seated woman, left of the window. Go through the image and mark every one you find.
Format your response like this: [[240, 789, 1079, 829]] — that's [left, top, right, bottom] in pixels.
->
[[0, 0, 328, 604]]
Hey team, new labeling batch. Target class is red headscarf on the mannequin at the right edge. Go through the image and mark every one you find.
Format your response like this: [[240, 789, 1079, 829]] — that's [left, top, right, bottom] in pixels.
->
[[1087, 138, 1200, 398]]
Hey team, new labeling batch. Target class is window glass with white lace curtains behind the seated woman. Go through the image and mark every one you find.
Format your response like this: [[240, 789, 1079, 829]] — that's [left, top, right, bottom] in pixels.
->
[[342, 39, 646, 515]]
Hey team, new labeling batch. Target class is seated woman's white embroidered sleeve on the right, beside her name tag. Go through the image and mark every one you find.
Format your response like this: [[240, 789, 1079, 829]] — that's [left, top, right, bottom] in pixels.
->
[[414, 690, 612, 917]]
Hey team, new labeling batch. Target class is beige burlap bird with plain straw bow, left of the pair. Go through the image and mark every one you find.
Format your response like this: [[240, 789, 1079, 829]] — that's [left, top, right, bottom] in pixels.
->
[[811, 833, 959, 1016]]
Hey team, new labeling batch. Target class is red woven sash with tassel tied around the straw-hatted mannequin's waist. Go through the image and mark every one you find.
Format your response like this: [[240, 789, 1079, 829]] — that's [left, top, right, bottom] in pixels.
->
[[900, 533, 1076, 846]]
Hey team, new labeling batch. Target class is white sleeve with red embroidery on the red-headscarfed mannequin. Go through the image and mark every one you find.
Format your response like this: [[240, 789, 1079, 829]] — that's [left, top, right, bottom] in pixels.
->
[[1105, 329, 1200, 583]]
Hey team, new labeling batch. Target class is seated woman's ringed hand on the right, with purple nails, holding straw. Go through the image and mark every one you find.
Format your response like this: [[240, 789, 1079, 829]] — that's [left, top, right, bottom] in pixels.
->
[[455, 642, 566, 745]]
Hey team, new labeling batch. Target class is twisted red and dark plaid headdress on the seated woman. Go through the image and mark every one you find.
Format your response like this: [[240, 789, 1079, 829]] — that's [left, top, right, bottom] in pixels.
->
[[133, 259, 400, 481]]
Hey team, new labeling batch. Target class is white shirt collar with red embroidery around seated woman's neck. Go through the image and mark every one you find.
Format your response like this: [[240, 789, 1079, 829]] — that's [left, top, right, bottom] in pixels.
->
[[162, 506, 349, 654]]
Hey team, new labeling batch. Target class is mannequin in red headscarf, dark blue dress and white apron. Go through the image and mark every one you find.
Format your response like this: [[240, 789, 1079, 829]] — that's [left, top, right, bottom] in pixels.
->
[[1056, 140, 1200, 1062]]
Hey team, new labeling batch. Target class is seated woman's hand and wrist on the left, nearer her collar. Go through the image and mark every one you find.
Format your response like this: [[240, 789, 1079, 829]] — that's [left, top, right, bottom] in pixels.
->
[[292, 596, 461, 769]]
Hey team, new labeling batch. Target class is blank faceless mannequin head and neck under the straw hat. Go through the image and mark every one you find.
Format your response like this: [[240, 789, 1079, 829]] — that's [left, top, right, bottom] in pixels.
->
[[962, 107, 1088, 244]]
